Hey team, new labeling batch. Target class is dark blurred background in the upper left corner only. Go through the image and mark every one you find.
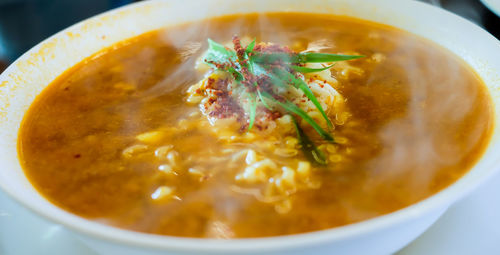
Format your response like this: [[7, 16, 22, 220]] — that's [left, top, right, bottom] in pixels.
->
[[0, 0, 140, 73]]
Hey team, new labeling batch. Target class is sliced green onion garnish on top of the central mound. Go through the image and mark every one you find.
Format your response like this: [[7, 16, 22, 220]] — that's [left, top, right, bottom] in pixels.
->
[[204, 36, 363, 165]]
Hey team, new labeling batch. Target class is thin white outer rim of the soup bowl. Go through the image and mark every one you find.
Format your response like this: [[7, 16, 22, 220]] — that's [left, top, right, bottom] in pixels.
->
[[0, 0, 500, 252]]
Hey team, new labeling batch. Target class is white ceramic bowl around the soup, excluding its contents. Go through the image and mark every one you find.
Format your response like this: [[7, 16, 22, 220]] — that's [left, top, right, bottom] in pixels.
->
[[0, 0, 500, 255]]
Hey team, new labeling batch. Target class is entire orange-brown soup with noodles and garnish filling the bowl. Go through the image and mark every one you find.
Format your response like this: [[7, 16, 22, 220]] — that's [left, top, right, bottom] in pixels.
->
[[19, 13, 493, 238]]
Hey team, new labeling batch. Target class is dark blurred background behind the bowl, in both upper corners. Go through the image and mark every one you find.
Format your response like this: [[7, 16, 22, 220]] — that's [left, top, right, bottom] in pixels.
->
[[0, 0, 500, 73]]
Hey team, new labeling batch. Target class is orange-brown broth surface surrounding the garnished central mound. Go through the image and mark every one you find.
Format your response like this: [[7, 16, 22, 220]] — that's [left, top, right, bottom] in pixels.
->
[[19, 13, 493, 238]]
